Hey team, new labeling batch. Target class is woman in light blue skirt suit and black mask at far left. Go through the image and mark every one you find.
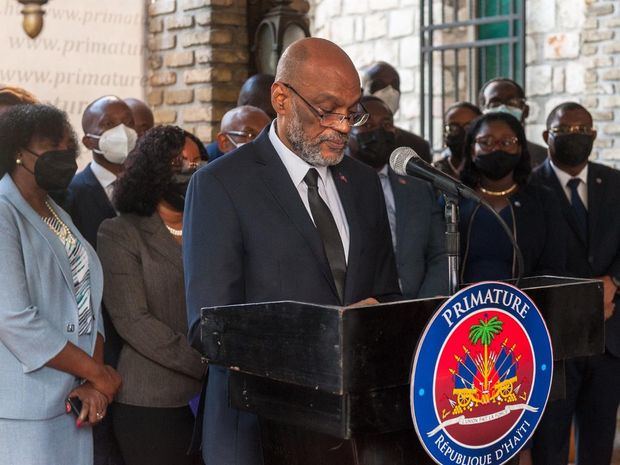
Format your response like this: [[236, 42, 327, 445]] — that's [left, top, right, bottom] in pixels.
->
[[0, 104, 121, 465]]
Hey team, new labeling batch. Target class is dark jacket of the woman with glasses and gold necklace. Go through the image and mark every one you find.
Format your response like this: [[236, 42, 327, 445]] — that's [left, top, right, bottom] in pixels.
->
[[459, 184, 566, 276]]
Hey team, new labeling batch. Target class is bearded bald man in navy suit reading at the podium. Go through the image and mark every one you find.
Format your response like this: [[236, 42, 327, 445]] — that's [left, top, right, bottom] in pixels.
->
[[183, 38, 399, 465]]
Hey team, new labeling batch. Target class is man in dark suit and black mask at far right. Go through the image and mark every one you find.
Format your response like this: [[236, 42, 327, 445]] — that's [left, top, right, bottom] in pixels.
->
[[532, 102, 620, 465]]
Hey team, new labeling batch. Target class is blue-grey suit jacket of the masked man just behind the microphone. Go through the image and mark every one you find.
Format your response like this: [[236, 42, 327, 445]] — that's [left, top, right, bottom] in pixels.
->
[[389, 169, 448, 299]]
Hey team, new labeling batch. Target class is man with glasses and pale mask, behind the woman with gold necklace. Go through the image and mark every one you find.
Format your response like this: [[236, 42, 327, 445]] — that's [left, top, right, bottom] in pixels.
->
[[478, 77, 547, 168]]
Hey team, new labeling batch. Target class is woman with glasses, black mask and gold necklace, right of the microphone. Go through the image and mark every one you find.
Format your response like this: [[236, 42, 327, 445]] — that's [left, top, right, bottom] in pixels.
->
[[460, 113, 566, 283]]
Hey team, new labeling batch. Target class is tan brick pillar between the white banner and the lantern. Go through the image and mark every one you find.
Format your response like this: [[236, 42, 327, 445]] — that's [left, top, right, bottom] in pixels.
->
[[147, 0, 249, 142]]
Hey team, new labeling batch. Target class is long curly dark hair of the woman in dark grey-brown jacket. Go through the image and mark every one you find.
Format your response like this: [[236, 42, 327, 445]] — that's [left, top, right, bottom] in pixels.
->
[[113, 126, 186, 216]]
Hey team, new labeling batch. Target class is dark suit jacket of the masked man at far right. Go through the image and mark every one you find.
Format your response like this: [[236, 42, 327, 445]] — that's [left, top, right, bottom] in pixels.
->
[[532, 161, 620, 357]]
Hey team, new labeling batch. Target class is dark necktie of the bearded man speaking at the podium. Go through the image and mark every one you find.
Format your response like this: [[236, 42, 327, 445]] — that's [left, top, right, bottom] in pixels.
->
[[304, 168, 347, 304]]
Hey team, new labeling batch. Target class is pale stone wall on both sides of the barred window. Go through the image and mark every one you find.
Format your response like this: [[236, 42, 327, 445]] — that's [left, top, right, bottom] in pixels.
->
[[310, 0, 620, 164]]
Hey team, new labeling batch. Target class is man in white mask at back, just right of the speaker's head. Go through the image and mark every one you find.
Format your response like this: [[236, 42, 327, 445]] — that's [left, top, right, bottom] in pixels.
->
[[362, 61, 433, 163]]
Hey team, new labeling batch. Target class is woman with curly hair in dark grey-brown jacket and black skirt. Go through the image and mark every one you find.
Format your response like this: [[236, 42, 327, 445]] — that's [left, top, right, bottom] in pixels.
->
[[97, 126, 205, 465]]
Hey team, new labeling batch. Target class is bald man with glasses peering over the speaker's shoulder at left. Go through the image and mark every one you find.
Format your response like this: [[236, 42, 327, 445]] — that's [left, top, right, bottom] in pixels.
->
[[217, 105, 271, 153]]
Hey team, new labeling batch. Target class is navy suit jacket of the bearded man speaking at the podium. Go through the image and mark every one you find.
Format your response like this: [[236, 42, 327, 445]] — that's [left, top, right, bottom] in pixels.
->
[[183, 127, 399, 465]]
